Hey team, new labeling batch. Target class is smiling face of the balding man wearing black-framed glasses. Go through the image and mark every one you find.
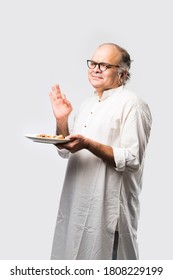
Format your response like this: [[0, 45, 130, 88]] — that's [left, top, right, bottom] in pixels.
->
[[88, 45, 121, 93]]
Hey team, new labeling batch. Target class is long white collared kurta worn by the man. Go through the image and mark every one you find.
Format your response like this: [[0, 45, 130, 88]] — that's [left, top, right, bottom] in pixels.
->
[[51, 86, 151, 260]]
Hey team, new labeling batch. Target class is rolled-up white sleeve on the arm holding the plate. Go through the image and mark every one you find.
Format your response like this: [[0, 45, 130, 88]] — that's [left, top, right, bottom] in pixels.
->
[[113, 100, 152, 171]]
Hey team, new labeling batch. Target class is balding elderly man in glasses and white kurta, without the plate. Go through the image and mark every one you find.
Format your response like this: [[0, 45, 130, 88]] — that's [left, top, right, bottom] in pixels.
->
[[50, 43, 152, 260]]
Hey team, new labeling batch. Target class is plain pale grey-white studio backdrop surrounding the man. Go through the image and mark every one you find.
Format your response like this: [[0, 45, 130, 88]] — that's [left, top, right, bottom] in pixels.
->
[[0, 0, 173, 260]]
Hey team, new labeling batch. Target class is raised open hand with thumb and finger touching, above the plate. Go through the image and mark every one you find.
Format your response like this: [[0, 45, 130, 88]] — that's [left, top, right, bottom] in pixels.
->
[[49, 84, 73, 122]]
